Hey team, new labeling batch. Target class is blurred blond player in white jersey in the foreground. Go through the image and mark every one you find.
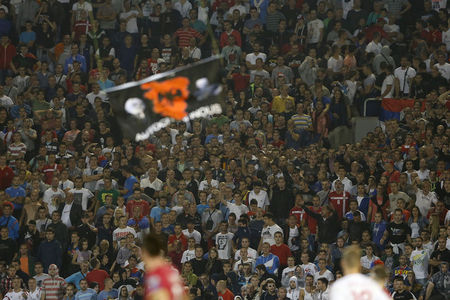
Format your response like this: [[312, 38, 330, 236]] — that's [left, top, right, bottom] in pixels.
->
[[330, 245, 391, 300]]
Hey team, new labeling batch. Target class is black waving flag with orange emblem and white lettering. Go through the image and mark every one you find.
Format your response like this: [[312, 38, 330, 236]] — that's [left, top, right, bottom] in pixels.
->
[[107, 56, 222, 141]]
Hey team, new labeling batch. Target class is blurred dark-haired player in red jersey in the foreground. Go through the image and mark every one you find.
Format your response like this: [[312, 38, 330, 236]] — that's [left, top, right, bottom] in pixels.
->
[[143, 234, 188, 300]]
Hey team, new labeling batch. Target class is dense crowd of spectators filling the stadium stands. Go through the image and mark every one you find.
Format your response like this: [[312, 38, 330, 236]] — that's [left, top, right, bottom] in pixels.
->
[[0, 0, 450, 300]]
